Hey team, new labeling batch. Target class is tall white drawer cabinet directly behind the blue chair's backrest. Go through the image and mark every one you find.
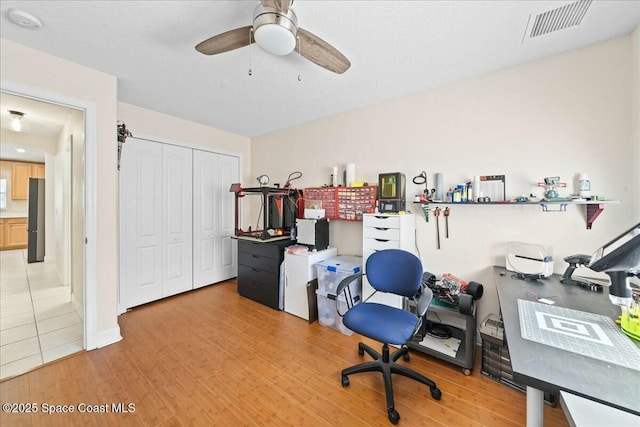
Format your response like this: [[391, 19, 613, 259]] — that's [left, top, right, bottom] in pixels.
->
[[362, 213, 416, 308]]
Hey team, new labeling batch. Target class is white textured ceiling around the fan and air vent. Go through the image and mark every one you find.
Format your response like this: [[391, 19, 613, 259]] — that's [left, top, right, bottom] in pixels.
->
[[0, 0, 640, 137]]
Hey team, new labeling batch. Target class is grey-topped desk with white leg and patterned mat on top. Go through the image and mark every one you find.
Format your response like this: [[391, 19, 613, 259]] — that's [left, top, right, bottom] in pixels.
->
[[493, 267, 640, 427]]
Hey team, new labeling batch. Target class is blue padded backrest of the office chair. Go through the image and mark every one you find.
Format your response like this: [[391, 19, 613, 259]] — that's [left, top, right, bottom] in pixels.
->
[[366, 249, 422, 298]]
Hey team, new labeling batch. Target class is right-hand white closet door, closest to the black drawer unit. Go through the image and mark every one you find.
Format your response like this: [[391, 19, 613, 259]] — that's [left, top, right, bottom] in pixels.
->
[[193, 150, 239, 288]]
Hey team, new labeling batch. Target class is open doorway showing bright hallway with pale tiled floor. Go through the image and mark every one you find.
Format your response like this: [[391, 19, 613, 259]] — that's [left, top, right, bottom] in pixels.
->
[[0, 90, 87, 379]]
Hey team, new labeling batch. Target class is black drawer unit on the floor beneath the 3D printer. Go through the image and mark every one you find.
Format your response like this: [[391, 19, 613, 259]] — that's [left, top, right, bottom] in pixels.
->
[[238, 238, 295, 310]]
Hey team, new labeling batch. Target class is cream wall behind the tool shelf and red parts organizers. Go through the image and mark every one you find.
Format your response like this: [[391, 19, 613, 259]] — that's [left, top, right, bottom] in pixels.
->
[[250, 37, 639, 319]]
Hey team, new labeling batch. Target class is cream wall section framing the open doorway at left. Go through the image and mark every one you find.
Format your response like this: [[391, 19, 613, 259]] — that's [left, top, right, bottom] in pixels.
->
[[0, 39, 120, 348]]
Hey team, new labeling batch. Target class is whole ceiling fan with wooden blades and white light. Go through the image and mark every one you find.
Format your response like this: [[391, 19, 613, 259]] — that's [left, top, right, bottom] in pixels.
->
[[196, 0, 351, 74]]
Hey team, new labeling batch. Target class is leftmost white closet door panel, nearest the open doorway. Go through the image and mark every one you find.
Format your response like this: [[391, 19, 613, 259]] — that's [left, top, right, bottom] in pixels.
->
[[120, 139, 163, 308]]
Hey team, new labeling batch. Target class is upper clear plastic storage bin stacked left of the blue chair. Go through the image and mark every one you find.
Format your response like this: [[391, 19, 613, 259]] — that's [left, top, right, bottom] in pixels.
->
[[316, 255, 362, 296]]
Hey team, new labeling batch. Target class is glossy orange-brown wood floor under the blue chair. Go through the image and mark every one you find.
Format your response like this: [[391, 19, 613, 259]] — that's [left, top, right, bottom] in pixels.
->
[[0, 282, 568, 427]]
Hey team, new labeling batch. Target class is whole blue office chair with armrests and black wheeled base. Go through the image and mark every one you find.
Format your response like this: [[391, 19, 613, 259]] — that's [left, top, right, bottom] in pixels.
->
[[336, 249, 442, 424]]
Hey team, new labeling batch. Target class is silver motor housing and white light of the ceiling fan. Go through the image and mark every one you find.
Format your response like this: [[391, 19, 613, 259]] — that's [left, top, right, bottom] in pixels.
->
[[253, 5, 298, 55]]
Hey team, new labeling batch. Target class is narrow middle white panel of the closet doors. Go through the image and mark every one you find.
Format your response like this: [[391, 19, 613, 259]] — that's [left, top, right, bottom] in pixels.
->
[[162, 144, 193, 297]]
